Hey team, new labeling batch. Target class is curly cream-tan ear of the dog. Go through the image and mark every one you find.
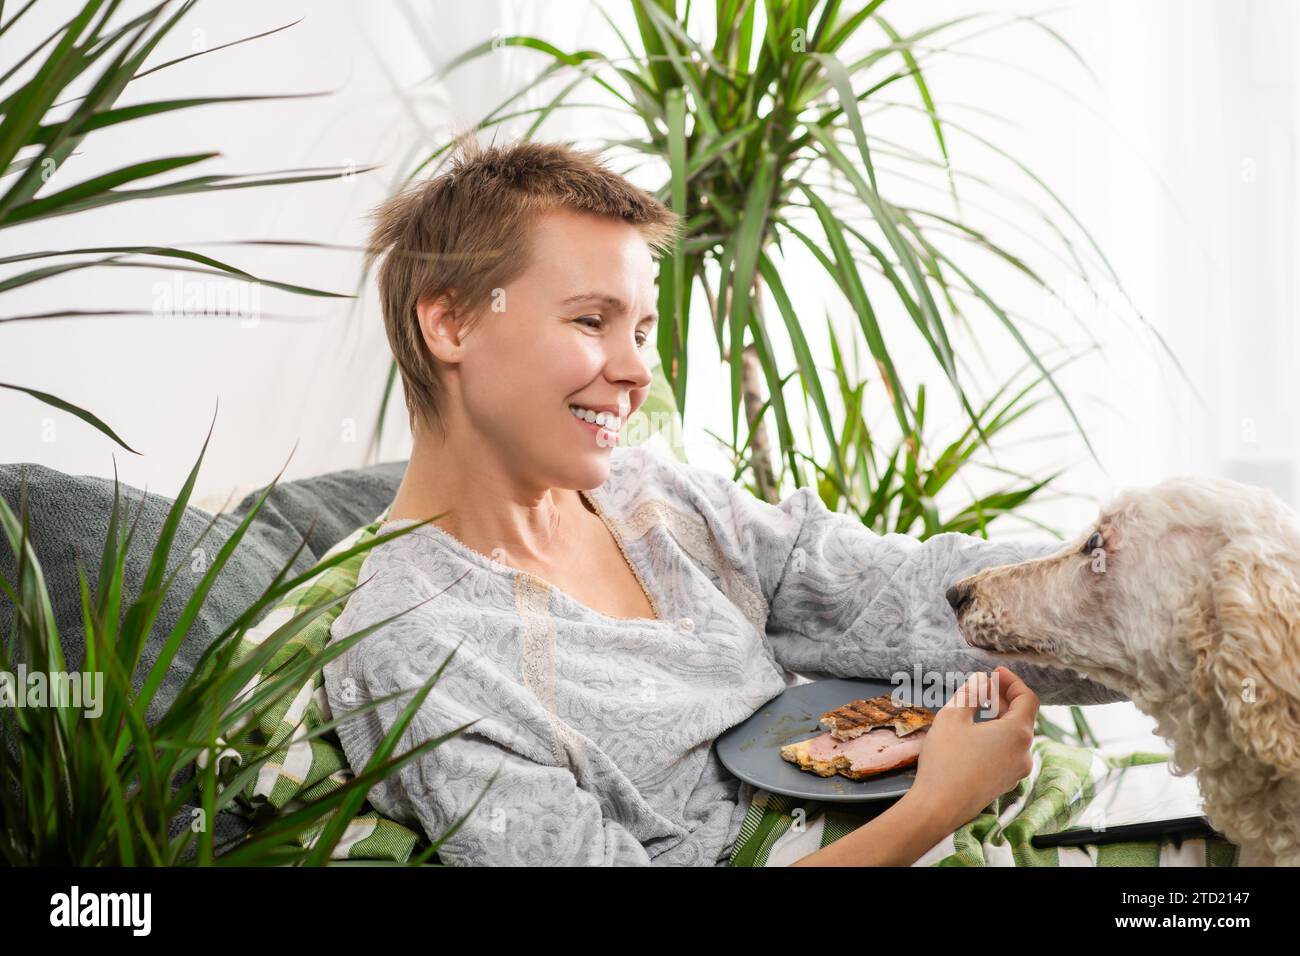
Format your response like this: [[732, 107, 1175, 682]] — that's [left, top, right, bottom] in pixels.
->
[[1188, 538, 1300, 773]]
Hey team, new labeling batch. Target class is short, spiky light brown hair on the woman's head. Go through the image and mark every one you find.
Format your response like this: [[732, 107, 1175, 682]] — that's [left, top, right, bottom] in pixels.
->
[[368, 130, 681, 433]]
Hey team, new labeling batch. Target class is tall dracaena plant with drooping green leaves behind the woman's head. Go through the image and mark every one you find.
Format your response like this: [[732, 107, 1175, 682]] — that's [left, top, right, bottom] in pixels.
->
[[381, 0, 1177, 512]]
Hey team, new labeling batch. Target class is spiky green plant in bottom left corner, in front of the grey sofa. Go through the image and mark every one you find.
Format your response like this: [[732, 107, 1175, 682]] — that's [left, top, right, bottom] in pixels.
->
[[0, 413, 483, 866]]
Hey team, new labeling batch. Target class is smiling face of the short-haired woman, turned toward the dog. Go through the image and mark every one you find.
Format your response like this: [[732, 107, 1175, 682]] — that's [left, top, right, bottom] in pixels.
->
[[444, 209, 657, 489]]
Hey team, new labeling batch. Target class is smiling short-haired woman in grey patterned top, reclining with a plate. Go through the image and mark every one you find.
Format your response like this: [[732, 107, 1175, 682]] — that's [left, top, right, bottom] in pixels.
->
[[325, 142, 1121, 865]]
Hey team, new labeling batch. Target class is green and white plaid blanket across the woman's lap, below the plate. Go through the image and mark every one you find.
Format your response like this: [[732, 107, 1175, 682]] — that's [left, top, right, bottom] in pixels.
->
[[729, 736, 1240, 866]]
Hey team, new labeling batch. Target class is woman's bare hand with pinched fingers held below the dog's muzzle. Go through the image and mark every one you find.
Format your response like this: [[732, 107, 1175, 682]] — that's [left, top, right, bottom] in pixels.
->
[[909, 666, 1039, 831]]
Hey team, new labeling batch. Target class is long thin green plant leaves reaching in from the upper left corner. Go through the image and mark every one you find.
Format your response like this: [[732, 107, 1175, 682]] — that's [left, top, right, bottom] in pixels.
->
[[0, 0, 373, 454]]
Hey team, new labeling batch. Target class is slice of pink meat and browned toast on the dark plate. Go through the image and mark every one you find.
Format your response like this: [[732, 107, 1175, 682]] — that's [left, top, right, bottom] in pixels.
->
[[781, 695, 935, 780]]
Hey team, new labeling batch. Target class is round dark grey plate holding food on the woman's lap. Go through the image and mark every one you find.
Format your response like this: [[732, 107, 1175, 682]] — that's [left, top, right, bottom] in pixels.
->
[[716, 678, 941, 803]]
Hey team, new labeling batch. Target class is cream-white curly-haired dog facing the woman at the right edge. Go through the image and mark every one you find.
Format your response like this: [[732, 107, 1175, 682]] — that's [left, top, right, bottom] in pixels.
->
[[948, 479, 1300, 866]]
